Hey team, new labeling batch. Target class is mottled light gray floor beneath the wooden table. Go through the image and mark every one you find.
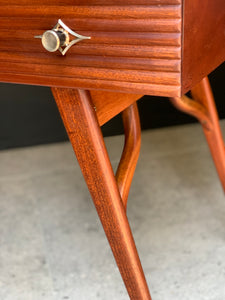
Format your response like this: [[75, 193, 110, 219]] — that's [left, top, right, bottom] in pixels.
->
[[0, 122, 225, 300]]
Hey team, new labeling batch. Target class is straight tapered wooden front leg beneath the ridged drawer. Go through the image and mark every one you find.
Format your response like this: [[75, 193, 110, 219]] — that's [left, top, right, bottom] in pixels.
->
[[52, 88, 151, 300]]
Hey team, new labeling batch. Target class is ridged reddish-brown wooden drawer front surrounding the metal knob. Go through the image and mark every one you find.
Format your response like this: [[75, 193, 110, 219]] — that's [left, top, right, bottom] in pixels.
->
[[0, 0, 182, 96]]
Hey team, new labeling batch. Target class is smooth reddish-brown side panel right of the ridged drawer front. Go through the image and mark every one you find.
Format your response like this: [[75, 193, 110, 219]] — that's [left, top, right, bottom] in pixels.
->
[[182, 0, 225, 94]]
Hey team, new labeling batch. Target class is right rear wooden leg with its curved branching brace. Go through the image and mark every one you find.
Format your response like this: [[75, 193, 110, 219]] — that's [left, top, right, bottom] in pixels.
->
[[171, 77, 225, 191]]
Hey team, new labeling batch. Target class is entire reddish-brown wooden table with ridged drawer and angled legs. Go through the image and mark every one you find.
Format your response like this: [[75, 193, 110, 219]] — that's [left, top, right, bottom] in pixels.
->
[[0, 0, 225, 300]]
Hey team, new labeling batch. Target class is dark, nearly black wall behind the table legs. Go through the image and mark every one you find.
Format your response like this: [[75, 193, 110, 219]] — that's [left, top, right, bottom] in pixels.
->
[[0, 64, 225, 149]]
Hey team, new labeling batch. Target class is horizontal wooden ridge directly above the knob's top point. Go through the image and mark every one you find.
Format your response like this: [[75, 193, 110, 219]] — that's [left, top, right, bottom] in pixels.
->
[[1, 4, 181, 22]]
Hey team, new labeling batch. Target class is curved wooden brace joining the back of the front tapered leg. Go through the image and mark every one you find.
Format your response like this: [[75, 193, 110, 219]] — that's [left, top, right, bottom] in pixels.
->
[[116, 102, 141, 208]]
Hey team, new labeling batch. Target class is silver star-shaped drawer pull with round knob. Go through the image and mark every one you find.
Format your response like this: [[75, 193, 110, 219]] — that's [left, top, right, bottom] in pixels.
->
[[35, 19, 91, 55]]
